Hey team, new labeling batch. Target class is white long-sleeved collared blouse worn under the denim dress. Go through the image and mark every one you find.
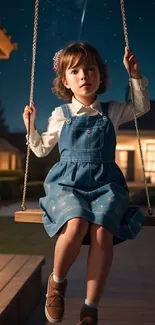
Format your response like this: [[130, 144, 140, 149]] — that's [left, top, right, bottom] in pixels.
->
[[26, 77, 150, 157]]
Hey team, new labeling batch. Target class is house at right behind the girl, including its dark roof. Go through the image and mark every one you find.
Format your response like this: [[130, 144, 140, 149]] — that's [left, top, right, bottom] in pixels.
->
[[116, 101, 155, 184]]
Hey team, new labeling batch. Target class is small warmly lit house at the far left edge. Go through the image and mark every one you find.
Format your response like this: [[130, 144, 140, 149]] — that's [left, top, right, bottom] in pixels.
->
[[0, 138, 23, 171]]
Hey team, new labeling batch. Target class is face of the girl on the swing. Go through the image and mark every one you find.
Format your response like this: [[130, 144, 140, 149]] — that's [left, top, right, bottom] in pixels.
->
[[63, 64, 101, 105]]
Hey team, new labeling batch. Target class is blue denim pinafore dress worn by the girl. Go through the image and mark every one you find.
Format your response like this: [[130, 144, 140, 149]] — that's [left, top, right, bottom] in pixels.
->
[[39, 103, 144, 244]]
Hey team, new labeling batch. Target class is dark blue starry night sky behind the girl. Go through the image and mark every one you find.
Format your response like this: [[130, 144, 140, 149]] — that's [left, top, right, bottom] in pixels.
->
[[0, 0, 155, 132]]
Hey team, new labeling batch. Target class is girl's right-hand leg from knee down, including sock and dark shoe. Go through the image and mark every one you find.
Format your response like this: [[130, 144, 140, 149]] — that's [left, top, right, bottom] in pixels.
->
[[78, 225, 113, 325]]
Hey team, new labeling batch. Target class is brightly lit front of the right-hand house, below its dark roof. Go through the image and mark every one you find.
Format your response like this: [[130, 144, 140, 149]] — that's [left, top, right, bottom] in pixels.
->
[[116, 130, 155, 184]]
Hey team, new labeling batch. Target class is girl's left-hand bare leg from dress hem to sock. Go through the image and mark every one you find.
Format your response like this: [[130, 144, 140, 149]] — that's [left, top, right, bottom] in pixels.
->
[[54, 217, 89, 278]]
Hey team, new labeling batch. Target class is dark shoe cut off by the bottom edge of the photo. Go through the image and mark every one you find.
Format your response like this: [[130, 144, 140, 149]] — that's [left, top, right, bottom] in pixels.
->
[[78, 304, 98, 325]]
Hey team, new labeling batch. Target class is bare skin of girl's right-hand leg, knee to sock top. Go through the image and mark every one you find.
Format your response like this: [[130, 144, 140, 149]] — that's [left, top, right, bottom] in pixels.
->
[[86, 224, 113, 306]]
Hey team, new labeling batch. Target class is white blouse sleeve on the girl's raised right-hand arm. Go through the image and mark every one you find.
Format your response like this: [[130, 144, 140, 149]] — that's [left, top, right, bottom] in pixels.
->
[[109, 77, 150, 131]]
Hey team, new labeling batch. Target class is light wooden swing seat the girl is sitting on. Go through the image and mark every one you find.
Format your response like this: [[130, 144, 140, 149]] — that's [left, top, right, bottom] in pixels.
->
[[15, 209, 155, 226]]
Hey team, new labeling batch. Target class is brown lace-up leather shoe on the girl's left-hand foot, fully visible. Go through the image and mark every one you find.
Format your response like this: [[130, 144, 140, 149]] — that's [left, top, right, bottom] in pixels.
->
[[45, 274, 67, 323]]
